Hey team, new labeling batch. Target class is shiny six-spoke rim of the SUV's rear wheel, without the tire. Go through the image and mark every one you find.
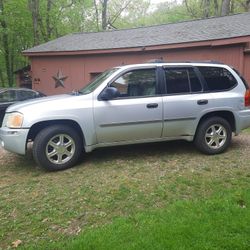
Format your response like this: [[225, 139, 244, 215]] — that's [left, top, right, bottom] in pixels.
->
[[205, 124, 227, 149]]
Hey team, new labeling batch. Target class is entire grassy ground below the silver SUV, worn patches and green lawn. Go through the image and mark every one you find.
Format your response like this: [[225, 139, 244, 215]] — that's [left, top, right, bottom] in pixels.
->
[[0, 131, 250, 249]]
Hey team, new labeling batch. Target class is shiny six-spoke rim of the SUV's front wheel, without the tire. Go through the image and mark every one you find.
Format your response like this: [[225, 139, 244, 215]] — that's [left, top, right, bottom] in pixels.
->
[[46, 134, 75, 165]]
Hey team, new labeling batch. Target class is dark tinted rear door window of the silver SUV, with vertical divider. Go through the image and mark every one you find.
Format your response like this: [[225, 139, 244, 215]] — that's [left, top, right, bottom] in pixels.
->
[[165, 68, 202, 94]]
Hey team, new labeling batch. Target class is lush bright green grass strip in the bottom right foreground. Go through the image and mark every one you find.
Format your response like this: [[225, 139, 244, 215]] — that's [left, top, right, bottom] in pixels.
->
[[30, 190, 250, 250]]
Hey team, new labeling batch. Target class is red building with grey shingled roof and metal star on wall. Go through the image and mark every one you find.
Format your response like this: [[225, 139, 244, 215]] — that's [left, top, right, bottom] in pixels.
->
[[23, 12, 250, 95]]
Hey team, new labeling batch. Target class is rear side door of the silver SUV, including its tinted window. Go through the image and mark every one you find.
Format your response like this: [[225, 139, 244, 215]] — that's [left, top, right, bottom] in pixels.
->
[[163, 66, 212, 137]]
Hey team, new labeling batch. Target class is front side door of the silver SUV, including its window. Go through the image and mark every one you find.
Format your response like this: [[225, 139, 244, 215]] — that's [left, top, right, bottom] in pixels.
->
[[94, 68, 163, 143]]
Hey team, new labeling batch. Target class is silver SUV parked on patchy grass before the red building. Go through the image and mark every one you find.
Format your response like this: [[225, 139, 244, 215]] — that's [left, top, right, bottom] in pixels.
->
[[0, 62, 250, 170]]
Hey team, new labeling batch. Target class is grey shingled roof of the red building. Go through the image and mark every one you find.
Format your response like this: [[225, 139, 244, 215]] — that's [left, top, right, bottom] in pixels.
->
[[23, 12, 250, 54]]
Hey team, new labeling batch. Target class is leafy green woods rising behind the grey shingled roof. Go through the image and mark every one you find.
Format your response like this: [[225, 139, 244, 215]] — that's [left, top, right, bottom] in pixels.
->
[[0, 0, 250, 86]]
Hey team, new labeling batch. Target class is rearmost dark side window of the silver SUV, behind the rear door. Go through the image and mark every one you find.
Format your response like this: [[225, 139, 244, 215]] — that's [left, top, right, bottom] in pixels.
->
[[198, 66, 237, 91]]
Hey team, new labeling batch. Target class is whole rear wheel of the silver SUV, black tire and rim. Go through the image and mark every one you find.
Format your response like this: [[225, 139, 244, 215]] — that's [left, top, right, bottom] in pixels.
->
[[194, 117, 232, 155]]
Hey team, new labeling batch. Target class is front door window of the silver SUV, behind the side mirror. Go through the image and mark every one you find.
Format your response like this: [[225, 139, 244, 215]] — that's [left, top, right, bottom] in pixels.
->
[[110, 69, 157, 97]]
